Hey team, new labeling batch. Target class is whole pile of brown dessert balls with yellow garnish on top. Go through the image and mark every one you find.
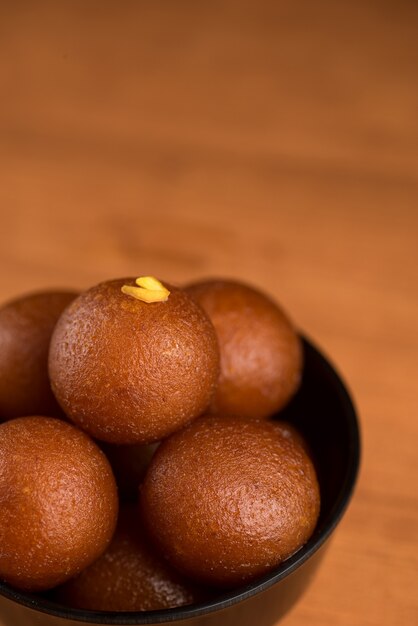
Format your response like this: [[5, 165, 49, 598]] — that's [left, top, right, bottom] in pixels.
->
[[0, 276, 320, 611]]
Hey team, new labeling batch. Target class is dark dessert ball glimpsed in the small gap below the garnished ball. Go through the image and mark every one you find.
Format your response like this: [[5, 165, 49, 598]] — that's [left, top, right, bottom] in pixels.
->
[[99, 441, 159, 500]]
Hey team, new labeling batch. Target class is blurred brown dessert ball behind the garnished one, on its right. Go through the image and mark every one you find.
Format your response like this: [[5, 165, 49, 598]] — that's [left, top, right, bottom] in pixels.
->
[[187, 280, 302, 417]]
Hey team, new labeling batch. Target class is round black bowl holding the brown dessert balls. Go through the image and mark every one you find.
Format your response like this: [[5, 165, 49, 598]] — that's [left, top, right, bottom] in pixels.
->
[[0, 339, 360, 626]]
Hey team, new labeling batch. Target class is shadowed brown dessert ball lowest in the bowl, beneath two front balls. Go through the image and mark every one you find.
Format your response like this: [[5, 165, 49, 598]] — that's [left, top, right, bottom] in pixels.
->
[[54, 506, 206, 611]]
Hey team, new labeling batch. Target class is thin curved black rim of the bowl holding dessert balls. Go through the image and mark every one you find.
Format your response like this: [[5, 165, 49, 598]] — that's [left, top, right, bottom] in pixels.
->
[[0, 335, 361, 626]]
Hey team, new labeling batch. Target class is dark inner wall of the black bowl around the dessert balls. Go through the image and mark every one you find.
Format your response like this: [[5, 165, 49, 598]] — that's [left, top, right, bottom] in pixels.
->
[[0, 339, 360, 624]]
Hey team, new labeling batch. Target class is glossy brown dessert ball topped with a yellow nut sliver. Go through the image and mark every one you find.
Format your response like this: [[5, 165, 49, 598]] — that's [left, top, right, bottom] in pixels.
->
[[49, 279, 219, 444]]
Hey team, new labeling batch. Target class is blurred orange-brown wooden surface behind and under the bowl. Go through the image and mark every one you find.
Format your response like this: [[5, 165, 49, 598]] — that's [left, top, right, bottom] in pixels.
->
[[0, 0, 418, 626]]
